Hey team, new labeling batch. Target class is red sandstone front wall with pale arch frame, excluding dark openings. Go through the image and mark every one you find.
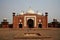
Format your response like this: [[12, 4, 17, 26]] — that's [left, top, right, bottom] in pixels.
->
[[13, 13, 48, 28]]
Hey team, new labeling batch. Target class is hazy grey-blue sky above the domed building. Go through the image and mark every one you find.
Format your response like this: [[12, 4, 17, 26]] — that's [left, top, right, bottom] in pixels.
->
[[0, 0, 60, 23]]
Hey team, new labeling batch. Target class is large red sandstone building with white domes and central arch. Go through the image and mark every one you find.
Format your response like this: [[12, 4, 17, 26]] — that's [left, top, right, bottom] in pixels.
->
[[13, 9, 48, 28]]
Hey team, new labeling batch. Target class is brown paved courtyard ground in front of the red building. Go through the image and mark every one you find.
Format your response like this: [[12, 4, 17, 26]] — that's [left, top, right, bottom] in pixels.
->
[[0, 28, 60, 40]]
